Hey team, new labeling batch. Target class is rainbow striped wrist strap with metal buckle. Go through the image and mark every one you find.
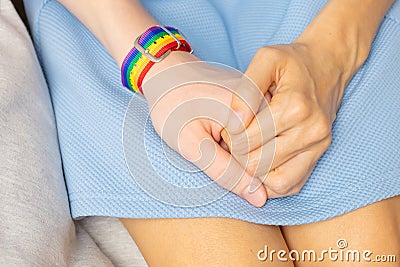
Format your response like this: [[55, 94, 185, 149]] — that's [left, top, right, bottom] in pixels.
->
[[121, 25, 193, 94]]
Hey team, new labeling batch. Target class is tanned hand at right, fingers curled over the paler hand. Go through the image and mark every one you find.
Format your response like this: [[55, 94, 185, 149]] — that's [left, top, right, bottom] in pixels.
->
[[222, 43, 349, 198]]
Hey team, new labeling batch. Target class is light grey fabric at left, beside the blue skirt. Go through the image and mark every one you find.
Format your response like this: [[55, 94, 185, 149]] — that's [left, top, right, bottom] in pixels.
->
[[0, 0, 145, 266]]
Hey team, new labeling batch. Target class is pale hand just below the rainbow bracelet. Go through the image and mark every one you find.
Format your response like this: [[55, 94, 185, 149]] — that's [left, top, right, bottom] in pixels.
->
[[143, 52, 266, 207]]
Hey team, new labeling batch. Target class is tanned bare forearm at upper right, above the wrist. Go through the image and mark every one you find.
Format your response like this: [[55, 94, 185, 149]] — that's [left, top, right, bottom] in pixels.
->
[[297, 0, 394, 76]]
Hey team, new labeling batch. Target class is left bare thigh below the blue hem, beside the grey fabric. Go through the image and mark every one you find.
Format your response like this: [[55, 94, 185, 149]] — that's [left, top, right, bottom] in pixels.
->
[[121, 218, 293, 266]]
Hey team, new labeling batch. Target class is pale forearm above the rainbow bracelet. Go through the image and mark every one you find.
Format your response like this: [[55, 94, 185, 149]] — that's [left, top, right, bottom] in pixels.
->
[[59, 0, 158, 66]]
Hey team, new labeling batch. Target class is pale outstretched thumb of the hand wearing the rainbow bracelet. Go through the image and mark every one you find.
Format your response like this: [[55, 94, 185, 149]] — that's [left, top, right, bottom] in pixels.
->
[[195, 137, 267, 207]]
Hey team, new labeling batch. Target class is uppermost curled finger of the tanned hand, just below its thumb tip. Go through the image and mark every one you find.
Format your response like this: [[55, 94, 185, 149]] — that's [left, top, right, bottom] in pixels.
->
[[236, 90, 320, 154]]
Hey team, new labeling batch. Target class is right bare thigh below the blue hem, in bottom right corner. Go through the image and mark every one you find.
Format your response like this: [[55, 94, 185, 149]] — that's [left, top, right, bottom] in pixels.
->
[[281, 196, 400, 267]]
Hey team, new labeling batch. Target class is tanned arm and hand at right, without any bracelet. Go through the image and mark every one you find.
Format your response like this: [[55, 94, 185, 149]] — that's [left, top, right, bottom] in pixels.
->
[[222, 0, 393, 198]]
